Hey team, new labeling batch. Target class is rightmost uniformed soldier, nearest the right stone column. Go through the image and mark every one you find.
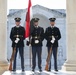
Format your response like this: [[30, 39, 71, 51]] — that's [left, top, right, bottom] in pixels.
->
[[45, 18, 61, 71]]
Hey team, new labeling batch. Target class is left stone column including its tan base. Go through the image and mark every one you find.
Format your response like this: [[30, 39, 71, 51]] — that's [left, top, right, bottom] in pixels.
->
[[0, 0, 8, 75]]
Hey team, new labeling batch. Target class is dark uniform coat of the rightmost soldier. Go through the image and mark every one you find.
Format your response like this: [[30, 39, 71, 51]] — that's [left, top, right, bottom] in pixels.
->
[[45, 27, 61, 47]]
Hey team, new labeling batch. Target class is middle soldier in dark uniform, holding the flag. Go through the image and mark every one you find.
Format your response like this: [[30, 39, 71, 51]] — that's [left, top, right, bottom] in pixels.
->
[[31, 18, 44, 72]]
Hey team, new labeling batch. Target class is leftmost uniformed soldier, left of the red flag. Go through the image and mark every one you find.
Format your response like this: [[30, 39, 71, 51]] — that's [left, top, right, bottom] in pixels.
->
[[10, 17, 25, 71]]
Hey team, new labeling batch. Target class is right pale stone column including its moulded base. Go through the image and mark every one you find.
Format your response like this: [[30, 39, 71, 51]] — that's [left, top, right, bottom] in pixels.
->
[[62, 0, 76, 71]]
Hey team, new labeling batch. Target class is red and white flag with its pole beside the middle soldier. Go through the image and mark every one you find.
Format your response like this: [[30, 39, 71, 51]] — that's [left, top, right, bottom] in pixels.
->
[[25, 0, 32, 67]]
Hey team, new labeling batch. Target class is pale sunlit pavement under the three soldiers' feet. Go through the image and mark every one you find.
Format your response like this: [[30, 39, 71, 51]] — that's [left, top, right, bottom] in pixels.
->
[[2, 70, 76, 75]]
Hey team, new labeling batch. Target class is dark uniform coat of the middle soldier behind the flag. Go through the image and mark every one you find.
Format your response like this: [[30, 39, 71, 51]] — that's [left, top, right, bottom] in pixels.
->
[[31, 27, 44, 46]]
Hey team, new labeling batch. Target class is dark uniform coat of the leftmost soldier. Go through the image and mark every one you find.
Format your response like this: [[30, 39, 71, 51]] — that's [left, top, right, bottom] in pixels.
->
[[10, 26, 25, 47]]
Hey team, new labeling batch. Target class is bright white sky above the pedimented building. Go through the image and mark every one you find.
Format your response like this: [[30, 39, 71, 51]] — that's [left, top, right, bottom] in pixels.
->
[[7, 0, 66, 11]]
